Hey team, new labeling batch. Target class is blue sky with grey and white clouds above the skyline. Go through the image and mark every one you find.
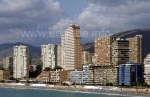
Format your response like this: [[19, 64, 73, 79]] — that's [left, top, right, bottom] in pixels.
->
[[0, 0, 150, 46]]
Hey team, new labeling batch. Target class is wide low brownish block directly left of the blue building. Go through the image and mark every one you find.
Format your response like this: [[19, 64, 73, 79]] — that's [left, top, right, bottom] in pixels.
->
[[89, 66, 118, 85]]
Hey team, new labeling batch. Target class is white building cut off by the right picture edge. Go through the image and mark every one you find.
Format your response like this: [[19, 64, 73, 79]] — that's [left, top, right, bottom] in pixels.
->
[[144, 54, 150, 85]]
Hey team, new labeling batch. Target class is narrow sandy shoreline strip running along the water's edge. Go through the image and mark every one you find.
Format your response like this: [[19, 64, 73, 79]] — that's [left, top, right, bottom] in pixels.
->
[[0, 83, 150, 97]]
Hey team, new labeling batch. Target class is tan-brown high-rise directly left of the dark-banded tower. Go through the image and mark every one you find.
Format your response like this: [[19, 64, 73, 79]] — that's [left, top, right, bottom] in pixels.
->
[[95, 37, 112, 66]]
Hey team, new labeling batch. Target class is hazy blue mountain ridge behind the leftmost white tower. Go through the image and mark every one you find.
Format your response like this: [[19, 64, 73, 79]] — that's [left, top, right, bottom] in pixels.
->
[[0, 42, 41, 60]]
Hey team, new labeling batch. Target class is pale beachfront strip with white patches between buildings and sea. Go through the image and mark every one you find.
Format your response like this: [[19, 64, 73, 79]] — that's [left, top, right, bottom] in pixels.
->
[[0, 83, 150, 97]]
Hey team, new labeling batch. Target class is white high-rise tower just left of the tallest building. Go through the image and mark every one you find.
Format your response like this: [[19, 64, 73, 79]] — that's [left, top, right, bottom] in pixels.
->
[[41, 44, 56, 70]]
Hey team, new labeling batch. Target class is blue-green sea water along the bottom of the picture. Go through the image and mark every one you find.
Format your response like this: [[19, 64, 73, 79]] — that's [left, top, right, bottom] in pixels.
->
[[0, 88, 143, 97]]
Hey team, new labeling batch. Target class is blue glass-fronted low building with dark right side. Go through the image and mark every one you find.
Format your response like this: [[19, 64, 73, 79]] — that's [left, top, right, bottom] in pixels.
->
[[119, 63, 143, 86]]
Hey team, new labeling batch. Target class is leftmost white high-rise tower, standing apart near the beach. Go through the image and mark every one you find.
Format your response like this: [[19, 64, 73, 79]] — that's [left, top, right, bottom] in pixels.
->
[[13, 45, 30, 78]]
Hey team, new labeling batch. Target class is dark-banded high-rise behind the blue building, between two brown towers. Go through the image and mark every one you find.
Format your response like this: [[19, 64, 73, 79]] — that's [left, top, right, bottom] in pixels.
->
[[112, 39, 129, 66]]
